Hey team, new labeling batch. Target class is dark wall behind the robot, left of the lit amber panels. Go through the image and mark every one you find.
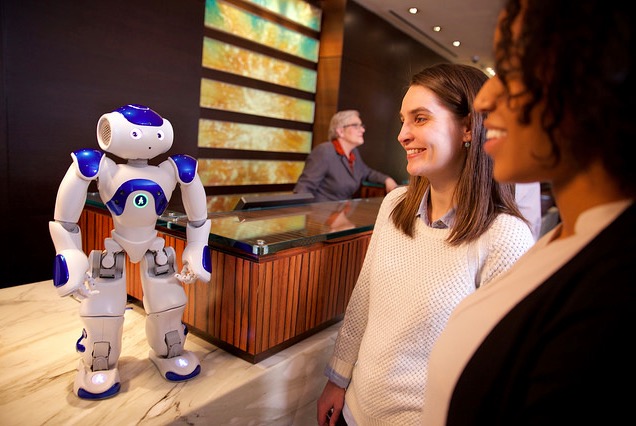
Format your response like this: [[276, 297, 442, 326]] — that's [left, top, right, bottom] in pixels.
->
[[0, 0, 205, 287]]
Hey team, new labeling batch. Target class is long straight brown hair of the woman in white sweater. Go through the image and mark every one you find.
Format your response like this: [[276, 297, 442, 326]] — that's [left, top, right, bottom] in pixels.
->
[[391, 63, 527, 245]]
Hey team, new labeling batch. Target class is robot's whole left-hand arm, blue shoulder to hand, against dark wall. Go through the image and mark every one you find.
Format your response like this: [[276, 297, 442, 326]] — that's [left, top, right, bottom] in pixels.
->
[[49, 149, 103, 299]]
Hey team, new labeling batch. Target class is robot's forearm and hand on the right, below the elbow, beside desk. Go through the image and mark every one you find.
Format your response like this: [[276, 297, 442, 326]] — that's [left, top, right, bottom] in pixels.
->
[[175, 219, 212, 284]]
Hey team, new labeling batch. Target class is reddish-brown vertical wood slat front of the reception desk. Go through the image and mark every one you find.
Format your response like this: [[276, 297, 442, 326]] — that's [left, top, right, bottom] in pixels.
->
[[79, 207, 371, 362]]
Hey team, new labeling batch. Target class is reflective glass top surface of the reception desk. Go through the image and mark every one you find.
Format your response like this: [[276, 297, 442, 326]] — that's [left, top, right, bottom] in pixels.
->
[[87, 192, 383, 255]]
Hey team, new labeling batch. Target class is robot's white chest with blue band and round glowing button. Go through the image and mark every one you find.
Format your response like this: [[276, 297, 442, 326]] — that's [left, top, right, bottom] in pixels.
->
[[98, 164, 176, 228]]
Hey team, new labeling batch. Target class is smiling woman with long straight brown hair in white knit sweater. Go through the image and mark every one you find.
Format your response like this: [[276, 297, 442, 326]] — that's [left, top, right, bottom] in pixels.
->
[[317, 64, 534, 426]]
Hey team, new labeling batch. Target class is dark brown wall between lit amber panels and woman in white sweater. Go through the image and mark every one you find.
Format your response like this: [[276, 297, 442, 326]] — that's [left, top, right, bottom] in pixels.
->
[[338, 1, 448, 182]]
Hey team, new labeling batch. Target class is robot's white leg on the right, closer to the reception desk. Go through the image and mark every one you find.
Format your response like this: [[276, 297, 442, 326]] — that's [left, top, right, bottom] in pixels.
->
[[141, 247, 201, 382]]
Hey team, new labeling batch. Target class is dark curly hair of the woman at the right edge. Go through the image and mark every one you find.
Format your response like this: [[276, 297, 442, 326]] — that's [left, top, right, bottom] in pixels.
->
[[495, 0, 636, 195]]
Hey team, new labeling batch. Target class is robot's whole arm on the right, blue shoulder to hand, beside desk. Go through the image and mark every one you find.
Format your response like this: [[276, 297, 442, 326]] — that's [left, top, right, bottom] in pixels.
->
[[164, 155, 212, 284]]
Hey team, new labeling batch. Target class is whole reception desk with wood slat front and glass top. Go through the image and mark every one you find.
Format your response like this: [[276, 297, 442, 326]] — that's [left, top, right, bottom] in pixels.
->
[[80, 194, 382, 363]]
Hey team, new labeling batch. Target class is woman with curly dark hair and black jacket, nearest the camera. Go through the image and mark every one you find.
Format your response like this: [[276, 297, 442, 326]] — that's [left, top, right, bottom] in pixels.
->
[[423, 0, 636, 425]]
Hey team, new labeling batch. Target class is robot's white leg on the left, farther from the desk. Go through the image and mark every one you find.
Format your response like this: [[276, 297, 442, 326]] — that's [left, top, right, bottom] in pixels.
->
[[73, 246, 126, 399]]
